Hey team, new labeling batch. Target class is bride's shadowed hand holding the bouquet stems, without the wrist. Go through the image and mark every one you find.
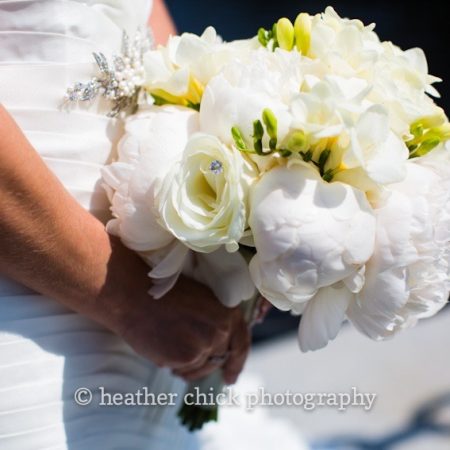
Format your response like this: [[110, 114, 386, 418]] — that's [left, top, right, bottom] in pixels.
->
[[115, 270, 250, 384]]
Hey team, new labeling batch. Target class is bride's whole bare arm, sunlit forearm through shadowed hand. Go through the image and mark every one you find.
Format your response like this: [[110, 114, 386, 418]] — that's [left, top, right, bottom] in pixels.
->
[[0, 106, 249, 381]]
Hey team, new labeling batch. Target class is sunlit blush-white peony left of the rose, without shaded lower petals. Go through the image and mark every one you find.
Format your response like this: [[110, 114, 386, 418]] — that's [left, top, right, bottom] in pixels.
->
[[102, 106, 198, 251]]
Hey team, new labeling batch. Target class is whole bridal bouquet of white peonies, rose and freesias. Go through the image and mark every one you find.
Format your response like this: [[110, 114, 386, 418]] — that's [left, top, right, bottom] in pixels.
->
[[67, 8, 450, 428]]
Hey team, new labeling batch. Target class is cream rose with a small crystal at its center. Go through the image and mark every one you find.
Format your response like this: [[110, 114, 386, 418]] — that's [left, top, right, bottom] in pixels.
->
[[158, 133, 252, 253]]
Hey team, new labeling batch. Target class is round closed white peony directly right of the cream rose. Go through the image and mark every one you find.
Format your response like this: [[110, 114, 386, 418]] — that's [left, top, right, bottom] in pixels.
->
[[249, 164, 375, 312]]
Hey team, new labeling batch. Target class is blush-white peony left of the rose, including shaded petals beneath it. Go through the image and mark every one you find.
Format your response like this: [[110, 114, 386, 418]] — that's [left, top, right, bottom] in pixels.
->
[[103, 106, 255, 306]]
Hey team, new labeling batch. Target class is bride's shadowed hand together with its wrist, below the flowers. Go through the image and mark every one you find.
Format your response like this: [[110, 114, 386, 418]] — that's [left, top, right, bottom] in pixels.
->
[[99, 237, 250, 384]]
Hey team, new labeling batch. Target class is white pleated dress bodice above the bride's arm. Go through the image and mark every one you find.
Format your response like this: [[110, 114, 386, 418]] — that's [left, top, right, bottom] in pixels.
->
[[0, 0, 151, 296]]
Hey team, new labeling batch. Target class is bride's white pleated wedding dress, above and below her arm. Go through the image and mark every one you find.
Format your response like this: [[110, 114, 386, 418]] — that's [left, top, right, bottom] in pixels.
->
[[0, 0, 196, 450]]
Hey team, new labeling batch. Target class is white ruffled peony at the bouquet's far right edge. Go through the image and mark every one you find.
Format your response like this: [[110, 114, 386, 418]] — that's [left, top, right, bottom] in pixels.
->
[[347, 147, 450, 339]]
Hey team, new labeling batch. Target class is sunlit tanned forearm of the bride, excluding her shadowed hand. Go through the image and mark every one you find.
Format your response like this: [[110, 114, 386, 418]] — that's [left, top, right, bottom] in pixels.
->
[[0, 104, 149, 330]]
